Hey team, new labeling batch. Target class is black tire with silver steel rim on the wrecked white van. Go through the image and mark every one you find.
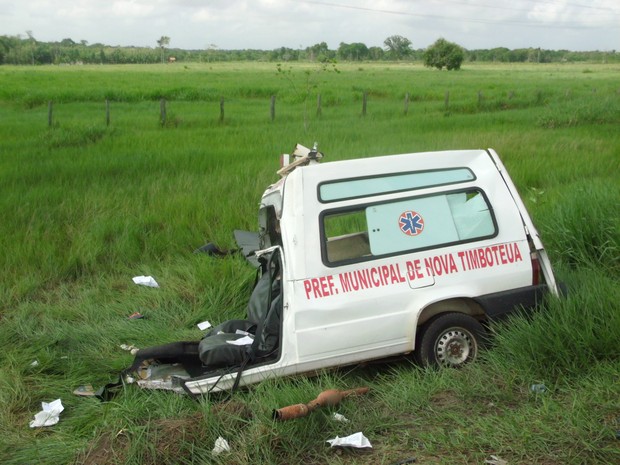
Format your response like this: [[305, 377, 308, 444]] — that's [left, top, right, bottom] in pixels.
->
[[416, 313, 485, 368]]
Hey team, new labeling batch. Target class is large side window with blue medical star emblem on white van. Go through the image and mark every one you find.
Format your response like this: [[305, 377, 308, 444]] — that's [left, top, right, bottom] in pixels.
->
[[322, 189, 497, 265]]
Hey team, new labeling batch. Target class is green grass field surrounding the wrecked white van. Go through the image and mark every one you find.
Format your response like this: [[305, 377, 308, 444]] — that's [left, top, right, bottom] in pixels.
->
[[0, 63, 620, 465]]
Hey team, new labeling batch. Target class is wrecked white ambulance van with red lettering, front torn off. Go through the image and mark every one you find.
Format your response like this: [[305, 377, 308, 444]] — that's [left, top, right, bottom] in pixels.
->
[[129, 145, 558, 394]]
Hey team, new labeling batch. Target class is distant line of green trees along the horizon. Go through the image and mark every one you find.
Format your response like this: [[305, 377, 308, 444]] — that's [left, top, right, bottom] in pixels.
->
[[0, 31, 620, 69]]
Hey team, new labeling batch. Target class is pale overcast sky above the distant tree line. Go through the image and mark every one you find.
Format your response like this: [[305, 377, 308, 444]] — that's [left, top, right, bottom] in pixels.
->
[[0, 0, 620, 51]]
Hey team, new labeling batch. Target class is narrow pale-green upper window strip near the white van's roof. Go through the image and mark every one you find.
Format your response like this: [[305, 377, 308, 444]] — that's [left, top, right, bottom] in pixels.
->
[[319, 168, 476, 203]]
